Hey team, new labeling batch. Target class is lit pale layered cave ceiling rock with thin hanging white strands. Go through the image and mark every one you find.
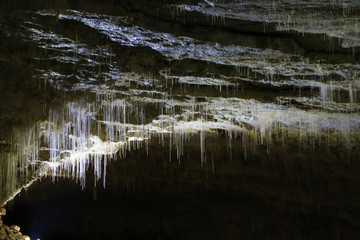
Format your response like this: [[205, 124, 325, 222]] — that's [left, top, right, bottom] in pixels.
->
[[0, 0, 360, 206]]
